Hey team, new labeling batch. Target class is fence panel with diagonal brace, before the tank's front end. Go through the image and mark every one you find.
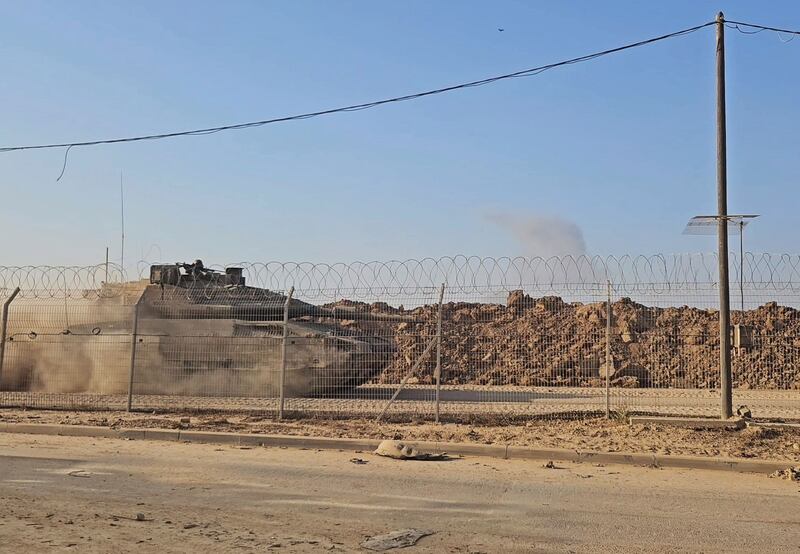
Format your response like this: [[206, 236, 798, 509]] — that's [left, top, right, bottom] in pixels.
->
[[287, 287, 439, 417]]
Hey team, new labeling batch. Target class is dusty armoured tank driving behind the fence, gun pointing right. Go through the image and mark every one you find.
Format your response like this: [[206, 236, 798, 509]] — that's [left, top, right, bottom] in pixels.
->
[[0, 260, 402, 397]]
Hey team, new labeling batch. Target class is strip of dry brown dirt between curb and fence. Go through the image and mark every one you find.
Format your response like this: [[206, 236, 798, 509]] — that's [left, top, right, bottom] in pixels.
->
[[0, 409, 800, 462]]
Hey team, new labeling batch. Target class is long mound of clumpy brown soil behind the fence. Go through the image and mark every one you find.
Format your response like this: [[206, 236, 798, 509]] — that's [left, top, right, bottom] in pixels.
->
[[324, 291, 800, 389]]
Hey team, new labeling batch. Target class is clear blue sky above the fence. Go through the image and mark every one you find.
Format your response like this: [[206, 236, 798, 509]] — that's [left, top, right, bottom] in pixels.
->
[[0, 0, 800, 265]]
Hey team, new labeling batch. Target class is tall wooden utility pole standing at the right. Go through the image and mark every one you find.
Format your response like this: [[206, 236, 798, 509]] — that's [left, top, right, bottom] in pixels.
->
[[717, 12, 733, 419]]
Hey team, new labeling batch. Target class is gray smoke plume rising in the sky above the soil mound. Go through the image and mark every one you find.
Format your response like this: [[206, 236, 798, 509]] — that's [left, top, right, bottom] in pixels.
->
[[485, 212, 586, 258]]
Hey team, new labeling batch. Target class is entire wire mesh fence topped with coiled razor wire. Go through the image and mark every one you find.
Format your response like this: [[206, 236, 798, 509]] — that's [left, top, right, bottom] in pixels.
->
[[0, 254, 800, 420]]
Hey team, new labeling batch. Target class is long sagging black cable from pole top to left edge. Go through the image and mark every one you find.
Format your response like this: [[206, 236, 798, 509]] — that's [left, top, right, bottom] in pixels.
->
[[0, 21, 716, 154]]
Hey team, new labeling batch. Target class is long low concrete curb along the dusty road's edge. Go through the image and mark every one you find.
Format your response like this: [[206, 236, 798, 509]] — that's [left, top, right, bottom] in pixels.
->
[[0, 423, 795, 473]]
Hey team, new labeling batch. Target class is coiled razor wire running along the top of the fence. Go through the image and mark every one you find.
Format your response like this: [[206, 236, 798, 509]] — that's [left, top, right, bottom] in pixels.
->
[[0, 253, 800, 300]]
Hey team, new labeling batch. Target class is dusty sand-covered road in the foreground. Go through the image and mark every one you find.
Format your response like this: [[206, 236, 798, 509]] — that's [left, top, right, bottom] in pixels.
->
[[0, 435, 800, 553]]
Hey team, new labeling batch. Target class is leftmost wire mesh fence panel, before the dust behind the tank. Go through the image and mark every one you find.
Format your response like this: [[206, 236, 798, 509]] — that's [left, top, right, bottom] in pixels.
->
[[0, 295, 131, 408]]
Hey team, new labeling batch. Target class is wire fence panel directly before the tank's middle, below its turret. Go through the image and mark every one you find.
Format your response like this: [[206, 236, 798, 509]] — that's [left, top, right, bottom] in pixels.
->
[[131, 282, 290, 411]]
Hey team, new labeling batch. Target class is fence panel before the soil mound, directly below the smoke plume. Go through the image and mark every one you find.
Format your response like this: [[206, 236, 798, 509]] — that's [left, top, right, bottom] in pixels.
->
[[424, 285, 606, 417]]
